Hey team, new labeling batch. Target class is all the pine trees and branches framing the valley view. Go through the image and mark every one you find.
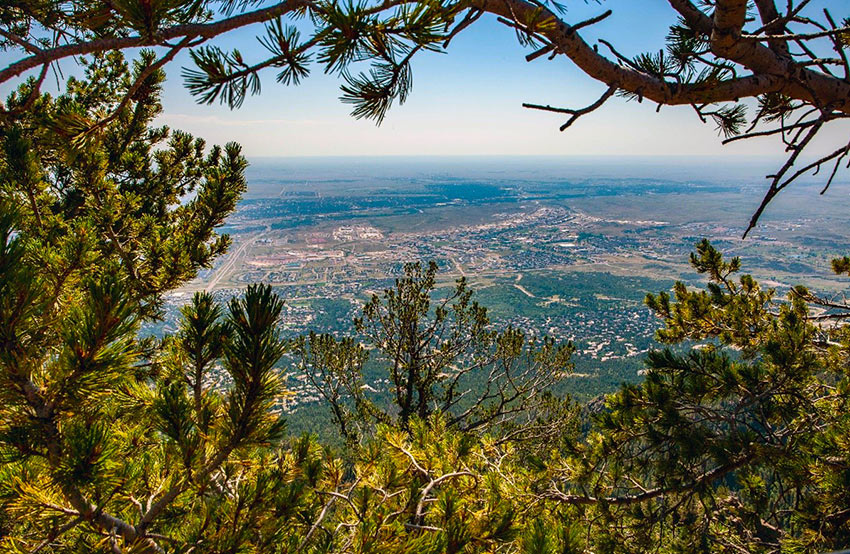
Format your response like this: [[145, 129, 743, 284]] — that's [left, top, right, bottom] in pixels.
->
[[0, 0, 850, 553]]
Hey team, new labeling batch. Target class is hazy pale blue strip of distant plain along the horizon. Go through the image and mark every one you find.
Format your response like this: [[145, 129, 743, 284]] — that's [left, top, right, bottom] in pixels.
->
[[238, 156, 850, 233]]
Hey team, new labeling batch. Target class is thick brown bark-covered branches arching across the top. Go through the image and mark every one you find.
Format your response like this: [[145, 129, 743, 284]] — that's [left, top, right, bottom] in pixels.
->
[[6, 0, 850, 113]]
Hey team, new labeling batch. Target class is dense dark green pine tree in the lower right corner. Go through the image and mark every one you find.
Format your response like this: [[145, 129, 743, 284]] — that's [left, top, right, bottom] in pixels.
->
[[536, 241, 850, 552]]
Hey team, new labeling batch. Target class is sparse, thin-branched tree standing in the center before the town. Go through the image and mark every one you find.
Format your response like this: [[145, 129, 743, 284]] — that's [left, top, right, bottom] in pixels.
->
[[299, 262, 573, 441]]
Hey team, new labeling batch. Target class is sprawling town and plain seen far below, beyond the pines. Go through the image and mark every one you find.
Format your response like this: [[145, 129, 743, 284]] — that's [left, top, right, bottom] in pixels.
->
[[146, 160, 846, 410]]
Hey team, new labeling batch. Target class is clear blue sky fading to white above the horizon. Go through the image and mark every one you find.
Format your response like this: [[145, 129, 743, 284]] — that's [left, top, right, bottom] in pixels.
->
[[0, 0, 848, 157]]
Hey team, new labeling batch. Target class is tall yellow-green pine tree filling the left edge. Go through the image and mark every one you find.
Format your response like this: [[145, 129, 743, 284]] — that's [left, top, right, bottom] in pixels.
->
[[0, 50, 316, 552]]
